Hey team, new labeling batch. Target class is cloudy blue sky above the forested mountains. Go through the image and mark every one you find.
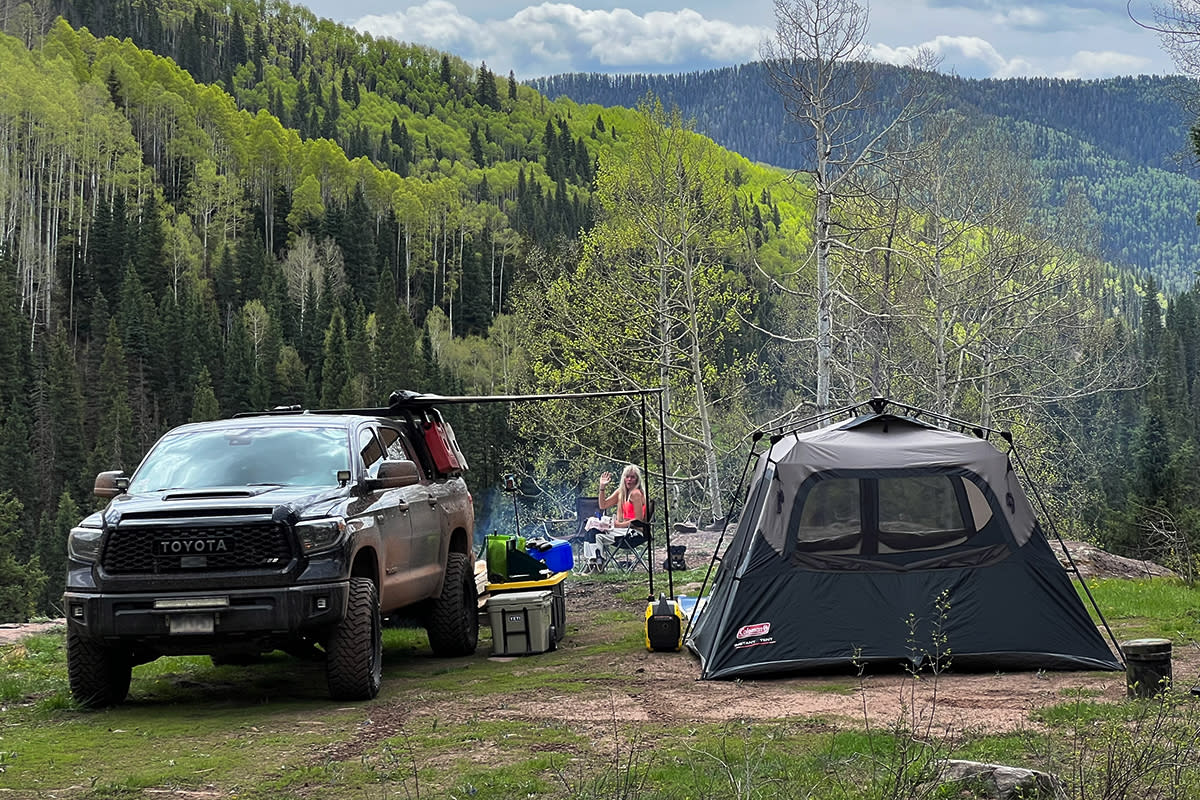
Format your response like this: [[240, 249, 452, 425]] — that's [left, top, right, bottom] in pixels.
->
[[299, 0, 1175, 79]]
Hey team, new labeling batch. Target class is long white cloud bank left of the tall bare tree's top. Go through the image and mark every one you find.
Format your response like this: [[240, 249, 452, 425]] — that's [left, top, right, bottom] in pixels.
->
[[353, 0, 772, 77]]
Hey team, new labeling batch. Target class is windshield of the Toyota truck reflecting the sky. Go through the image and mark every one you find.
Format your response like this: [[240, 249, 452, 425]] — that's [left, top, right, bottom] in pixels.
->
[[130, 426, 350, 494]]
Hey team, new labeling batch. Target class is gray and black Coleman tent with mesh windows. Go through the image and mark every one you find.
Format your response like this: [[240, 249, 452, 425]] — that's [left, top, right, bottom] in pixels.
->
[[688, 413, 1121, 678]]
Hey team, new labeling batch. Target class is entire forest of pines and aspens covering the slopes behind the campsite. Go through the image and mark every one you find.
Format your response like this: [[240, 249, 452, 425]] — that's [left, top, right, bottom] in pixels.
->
[[0, 0, 1200, 621]]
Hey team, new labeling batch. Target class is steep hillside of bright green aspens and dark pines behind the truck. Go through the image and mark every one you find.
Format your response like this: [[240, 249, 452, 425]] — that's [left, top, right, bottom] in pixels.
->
[[0, 2, 806, 618]]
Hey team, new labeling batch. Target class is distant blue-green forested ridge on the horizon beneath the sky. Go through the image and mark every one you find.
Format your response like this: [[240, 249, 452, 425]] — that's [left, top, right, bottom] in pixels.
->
[[540, 64, 1200, 290]]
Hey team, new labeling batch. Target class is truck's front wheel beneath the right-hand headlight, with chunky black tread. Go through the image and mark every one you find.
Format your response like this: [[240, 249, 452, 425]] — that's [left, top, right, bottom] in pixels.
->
[[325, 578, 383, 700]]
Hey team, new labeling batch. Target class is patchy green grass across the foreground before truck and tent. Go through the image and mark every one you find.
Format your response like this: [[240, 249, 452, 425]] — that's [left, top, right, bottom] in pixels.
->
[[7, 570, 1200, 800]]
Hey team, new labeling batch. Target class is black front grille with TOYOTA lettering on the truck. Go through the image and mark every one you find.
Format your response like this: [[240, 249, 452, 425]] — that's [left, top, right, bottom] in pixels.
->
[[101, 521, 293, 575]]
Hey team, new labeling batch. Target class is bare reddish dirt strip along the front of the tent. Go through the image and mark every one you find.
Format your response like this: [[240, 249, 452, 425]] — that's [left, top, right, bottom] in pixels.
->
[[453, 579, 1200, 733]]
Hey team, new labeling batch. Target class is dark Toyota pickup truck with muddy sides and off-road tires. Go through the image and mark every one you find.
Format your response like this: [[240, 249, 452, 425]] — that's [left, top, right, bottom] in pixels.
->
[[64, 396, 479, 708]]
